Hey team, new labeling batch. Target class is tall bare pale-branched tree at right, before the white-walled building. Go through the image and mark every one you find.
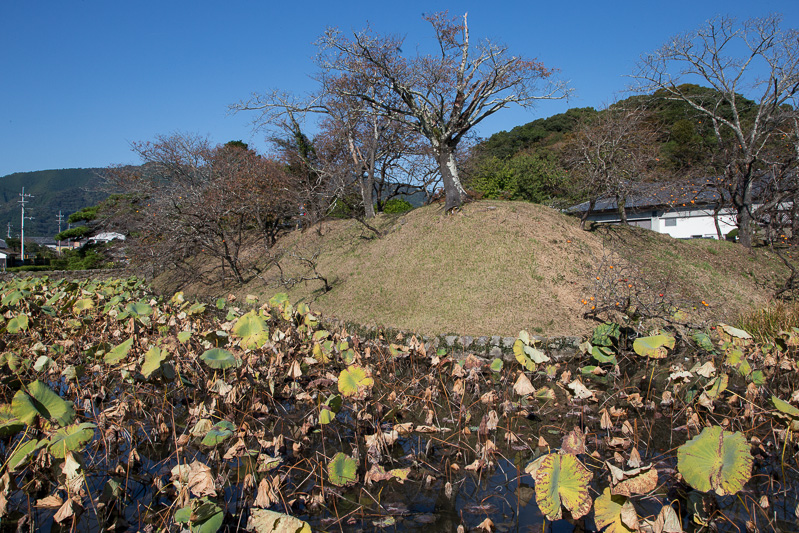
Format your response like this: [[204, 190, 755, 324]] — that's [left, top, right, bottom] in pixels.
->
[[633, 15, 799, 247]]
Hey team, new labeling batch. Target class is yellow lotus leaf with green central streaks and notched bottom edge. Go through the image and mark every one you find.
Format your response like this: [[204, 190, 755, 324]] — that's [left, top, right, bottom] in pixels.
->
[[534, 453, 593, 520]]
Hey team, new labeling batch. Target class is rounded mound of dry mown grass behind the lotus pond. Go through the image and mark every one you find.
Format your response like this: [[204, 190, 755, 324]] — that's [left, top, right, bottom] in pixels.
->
[[170, 201, 786, 335]]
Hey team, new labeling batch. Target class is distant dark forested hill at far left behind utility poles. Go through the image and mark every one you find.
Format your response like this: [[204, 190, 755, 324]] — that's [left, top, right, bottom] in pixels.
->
[[0, 168, 108, 238]]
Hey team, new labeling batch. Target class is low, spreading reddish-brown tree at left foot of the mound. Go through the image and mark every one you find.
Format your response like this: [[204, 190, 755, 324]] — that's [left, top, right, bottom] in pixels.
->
[[105, 135, 295, 283]]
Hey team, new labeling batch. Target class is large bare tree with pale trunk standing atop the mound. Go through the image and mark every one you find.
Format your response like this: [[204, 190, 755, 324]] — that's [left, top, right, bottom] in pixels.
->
[[308, 13, 567, 210]]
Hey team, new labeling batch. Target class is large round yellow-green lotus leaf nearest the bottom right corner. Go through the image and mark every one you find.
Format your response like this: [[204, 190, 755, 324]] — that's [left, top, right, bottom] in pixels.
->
[[677, 426, 753, 496]]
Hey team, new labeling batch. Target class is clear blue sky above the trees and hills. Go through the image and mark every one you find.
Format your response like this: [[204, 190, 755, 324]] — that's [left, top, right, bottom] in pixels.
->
[[0, 0, 799, 176]]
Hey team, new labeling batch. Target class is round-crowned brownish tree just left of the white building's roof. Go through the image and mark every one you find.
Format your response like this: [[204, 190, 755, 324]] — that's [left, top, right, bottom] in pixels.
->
[[563, 105, 657, 229]]
